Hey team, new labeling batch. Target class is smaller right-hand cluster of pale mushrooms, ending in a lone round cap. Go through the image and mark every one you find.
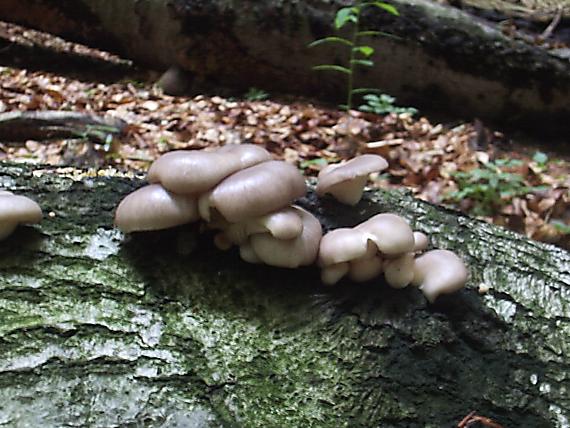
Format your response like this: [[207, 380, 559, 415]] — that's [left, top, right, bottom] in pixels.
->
[[318, 213, 467, 302]]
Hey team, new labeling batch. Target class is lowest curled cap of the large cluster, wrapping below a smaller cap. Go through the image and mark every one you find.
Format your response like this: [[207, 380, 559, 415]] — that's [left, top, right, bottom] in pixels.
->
[[249, 207, 322, 268]]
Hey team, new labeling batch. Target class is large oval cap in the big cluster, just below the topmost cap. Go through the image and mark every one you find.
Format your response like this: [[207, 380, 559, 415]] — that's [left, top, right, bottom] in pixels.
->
[[206, 161, 307, 223]]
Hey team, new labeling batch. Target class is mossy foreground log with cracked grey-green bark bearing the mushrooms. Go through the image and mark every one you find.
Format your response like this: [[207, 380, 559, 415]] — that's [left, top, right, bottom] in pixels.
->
[[0, 164, 570, 427]]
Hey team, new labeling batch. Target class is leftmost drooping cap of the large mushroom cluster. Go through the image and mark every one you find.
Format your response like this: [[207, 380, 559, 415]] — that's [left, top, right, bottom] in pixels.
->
[[115, 184, 199, 233]]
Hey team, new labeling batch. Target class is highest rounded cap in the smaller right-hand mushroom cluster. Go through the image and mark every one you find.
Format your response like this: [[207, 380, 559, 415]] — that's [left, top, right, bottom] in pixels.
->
[[355, 213, 414, 256]]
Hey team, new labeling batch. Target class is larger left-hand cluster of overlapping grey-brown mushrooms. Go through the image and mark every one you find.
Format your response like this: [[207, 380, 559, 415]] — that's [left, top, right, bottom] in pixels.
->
[[115, 144, 322, 268]]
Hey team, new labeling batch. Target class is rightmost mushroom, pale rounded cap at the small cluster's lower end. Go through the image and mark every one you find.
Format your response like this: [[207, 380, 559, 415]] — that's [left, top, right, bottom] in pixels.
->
[[412, 250, 468, 303]]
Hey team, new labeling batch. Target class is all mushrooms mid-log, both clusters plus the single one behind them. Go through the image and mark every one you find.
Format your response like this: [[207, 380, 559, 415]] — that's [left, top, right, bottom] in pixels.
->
[[115, 149, 467, 302]]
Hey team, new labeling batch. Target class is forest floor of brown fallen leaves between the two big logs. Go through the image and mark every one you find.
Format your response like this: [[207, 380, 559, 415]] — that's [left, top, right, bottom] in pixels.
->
[[0, 23, 570, 249]]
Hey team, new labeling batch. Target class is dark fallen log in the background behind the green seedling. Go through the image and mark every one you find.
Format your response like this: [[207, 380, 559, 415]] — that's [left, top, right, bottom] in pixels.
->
[[0, 0, 570, 134]]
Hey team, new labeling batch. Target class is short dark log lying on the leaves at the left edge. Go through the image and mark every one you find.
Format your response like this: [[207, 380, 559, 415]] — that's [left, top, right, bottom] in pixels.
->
[[0, 110, 127, 143]]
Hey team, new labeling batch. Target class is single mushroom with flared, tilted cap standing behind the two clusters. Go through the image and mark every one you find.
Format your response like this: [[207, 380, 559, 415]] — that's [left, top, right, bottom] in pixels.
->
[[317, 155, 388, 205]]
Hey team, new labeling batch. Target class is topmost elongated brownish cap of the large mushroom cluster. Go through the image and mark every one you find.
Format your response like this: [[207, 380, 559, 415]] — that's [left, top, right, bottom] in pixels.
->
[[148, 144, 271, 195]]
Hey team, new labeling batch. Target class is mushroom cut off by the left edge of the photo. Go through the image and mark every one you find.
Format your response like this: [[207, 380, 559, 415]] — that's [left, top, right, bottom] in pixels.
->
[[0, 190, 42, 240]]
